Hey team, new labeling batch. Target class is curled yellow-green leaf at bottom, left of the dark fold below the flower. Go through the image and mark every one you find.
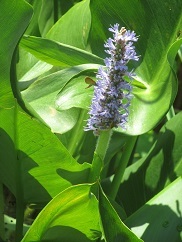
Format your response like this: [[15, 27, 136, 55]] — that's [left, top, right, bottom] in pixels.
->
[[22, 184, 101, 242]]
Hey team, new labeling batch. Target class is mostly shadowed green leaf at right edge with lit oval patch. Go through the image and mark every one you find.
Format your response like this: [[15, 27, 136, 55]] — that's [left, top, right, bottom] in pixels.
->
[[119, 112, 182, 214]]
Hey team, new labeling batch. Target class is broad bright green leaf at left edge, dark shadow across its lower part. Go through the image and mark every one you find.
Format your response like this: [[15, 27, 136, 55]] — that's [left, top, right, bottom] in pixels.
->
[[0, 106, 90, 203]]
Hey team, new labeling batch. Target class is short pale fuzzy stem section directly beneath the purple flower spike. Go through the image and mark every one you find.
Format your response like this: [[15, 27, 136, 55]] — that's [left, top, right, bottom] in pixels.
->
[[95, 129, 112, 160]]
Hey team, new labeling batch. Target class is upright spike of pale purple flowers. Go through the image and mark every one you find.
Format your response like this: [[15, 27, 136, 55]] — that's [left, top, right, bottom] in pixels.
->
[[84, 24, 139, 135]]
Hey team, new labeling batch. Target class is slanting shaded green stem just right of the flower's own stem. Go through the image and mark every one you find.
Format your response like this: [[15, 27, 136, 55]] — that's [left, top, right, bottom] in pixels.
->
[[109, 136, 137, 200]]
